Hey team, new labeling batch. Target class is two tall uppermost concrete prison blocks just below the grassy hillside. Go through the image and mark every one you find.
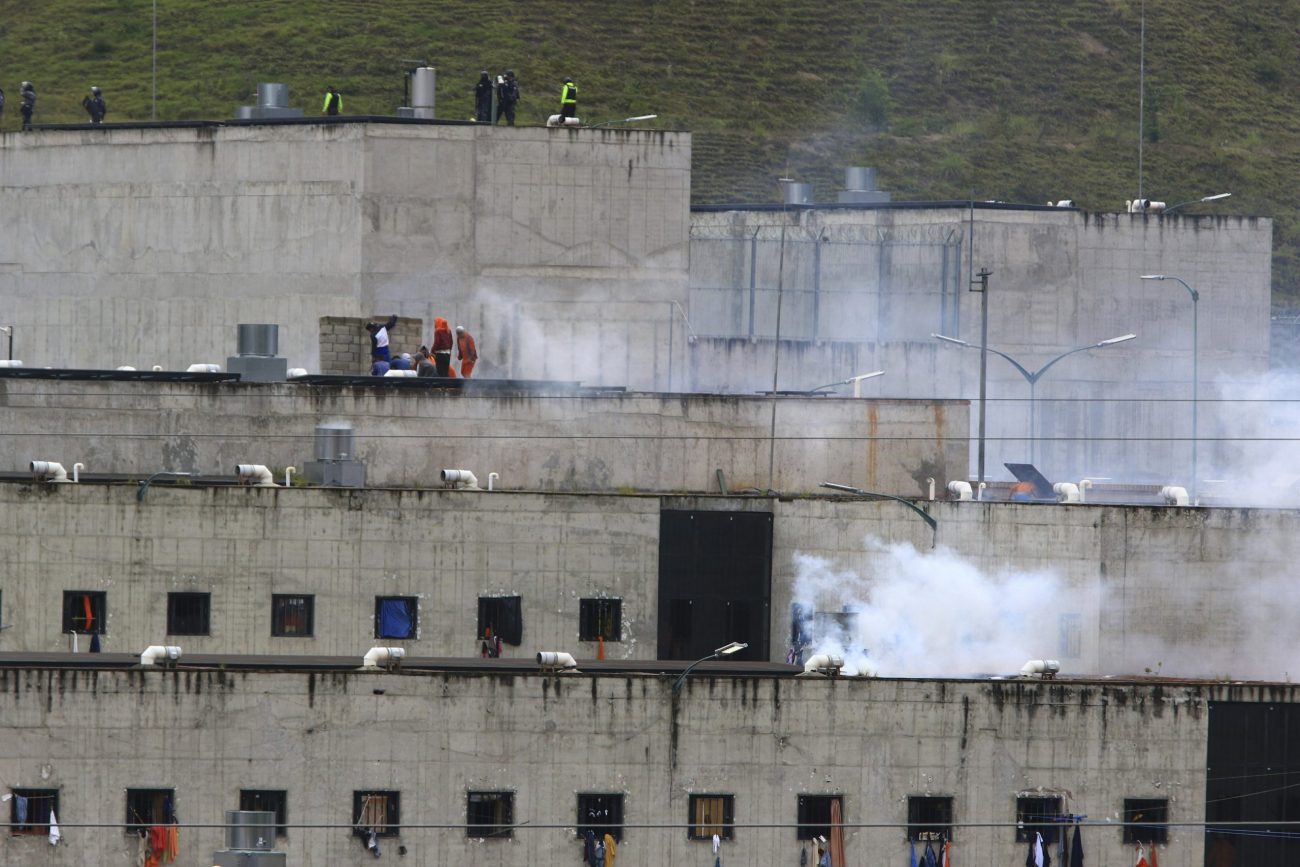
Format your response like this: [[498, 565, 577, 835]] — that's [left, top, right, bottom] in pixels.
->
[[0, 120, 1271, 489]]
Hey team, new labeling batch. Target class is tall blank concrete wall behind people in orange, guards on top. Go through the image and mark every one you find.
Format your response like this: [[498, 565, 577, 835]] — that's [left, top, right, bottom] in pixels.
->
[[0, 123, 690, 387]]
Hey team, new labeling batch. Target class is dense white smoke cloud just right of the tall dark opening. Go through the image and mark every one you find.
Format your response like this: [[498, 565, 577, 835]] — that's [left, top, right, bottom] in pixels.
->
[[793, 539, 1061, 677]]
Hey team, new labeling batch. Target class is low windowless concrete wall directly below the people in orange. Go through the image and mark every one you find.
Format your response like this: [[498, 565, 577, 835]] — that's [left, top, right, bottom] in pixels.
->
[[0, 378, 969, 497]]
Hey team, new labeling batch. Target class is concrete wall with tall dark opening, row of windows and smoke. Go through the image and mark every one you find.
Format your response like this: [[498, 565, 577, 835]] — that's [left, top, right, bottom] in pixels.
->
[[0, 484, 1300, 680]]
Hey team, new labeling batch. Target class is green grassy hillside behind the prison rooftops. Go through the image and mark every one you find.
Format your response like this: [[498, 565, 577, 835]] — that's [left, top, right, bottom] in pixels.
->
[[0, 0, 1300, 307]]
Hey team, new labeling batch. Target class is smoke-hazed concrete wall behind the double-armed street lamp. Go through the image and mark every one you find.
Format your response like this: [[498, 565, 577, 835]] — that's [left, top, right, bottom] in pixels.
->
[[686, 208, 1271, 485]]
